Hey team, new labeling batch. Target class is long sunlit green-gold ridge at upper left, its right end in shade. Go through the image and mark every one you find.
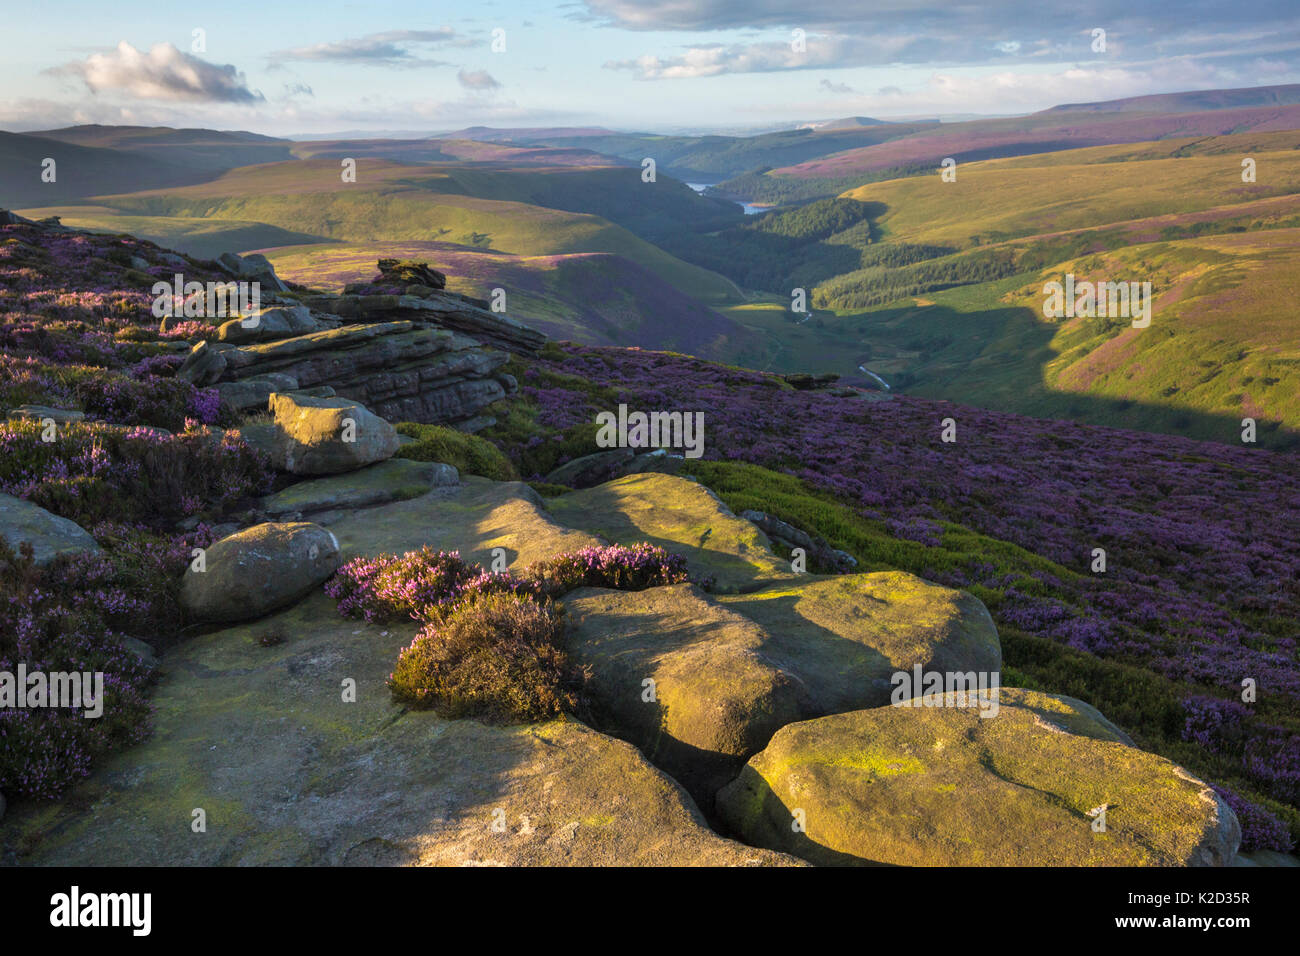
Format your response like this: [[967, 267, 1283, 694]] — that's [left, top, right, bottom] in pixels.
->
[[15, 159, 741, 303]]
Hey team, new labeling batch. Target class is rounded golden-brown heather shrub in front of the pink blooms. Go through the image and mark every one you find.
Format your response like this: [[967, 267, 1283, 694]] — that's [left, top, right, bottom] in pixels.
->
[[389, 593, 577, 723]]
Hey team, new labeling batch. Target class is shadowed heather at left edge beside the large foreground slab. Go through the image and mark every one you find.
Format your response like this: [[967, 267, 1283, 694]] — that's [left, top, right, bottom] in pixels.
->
[[0, 524, 211, 799]]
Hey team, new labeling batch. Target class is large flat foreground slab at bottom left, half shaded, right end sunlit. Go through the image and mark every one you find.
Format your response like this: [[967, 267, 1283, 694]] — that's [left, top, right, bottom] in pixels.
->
[[4, 593, 798, 866]]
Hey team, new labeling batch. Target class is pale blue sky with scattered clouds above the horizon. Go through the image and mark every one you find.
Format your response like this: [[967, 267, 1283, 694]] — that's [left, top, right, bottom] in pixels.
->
[[0, 0, 1300, 135]]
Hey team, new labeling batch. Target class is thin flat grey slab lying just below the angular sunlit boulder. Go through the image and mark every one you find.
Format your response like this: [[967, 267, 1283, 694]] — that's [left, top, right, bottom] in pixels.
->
[[261, 458, 460, 515]]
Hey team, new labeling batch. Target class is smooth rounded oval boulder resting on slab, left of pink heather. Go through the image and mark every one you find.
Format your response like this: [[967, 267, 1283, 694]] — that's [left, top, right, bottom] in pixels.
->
[[181, 522, 342, 622]]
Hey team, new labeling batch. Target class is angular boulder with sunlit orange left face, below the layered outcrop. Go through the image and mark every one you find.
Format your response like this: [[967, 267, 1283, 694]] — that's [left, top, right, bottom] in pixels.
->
[[269, 393, 399, 475]]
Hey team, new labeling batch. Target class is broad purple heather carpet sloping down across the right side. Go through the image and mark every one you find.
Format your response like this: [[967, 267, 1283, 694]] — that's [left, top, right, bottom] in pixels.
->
[[484, 345, 1300, 848]]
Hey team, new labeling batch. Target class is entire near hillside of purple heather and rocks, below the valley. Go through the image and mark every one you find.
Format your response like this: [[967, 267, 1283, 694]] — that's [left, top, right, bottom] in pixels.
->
[[0, 221, 1300, 865]]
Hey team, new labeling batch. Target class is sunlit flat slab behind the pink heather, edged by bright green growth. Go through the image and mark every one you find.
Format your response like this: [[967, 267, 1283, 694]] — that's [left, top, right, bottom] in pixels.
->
[[547, 473, 796, 592]]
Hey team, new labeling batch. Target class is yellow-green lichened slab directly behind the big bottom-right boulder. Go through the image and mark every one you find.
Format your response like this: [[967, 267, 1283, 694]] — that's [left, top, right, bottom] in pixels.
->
[[716, 571, 1002, 714]]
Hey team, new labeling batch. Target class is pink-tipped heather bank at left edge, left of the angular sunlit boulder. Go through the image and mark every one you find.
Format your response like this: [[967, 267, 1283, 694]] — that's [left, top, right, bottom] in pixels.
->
[[0, 421, 272, 523]]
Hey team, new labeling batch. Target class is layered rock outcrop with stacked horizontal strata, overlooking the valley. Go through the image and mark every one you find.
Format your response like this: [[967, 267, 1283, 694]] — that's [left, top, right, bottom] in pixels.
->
[[170, 254, 546, 431]]
